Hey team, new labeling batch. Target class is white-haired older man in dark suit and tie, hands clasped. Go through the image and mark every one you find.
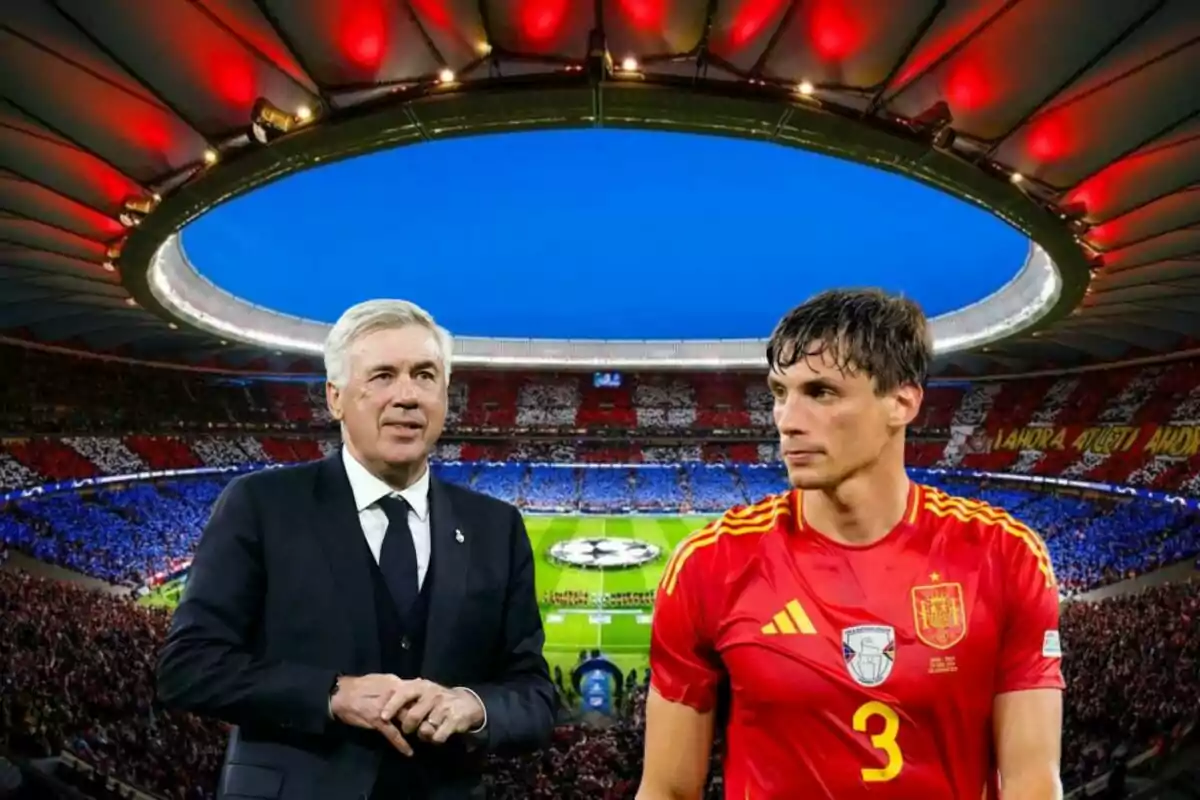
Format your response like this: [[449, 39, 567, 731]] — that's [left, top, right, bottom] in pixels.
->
[[158, 300, 554, 800]]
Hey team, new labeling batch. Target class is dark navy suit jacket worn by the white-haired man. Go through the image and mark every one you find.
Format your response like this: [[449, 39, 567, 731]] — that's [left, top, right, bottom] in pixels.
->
[[158, 453, 554, 800]]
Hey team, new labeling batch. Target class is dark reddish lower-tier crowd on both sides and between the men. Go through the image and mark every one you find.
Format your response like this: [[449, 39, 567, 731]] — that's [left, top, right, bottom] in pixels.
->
[[0, 570, 1200, 800]]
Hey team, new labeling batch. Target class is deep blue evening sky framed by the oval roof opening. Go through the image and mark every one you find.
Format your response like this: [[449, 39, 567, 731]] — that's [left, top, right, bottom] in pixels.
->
[[184, 130, 1027, 339]]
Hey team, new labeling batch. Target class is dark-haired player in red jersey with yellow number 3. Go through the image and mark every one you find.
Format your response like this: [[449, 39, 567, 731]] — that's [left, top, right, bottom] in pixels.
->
[[637, 290, 1063, 800]]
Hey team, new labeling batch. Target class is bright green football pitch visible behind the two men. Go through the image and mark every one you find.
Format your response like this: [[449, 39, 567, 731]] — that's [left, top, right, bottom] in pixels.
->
[[142, 515, 712, 674]]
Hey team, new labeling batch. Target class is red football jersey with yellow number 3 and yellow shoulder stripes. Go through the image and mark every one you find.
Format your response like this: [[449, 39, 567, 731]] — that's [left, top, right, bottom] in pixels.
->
[[650, 483, 1063, 800]]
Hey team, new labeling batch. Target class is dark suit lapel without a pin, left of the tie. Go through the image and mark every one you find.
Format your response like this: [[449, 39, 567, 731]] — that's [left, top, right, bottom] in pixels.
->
[[313, 452, 382, 672]]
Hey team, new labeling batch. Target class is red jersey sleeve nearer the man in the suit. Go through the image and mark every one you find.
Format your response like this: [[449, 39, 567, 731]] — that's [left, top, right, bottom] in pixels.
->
[[650, 539, 721, 711]]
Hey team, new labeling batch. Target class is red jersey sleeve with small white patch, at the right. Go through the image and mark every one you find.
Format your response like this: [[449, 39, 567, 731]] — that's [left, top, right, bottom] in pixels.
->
[[996, 521, 1064, 694]]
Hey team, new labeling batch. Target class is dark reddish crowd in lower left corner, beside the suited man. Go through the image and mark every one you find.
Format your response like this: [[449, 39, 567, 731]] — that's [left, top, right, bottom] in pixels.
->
[[0, 570, 223, 800]]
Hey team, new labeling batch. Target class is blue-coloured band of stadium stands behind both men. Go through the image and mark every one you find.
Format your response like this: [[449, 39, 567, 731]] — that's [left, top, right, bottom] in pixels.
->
[[0, 463, 1200, 591]]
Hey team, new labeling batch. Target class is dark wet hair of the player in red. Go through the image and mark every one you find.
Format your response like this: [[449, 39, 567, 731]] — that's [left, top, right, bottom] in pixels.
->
[[767, 289, 934, 395]]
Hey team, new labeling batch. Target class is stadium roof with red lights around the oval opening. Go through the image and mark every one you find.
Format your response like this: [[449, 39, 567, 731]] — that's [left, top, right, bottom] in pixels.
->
[[0, 0, 1200, 374]]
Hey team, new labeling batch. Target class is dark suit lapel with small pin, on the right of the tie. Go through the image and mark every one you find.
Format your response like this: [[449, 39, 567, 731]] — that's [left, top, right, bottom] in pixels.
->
[[421, 477, 472, 675]]
